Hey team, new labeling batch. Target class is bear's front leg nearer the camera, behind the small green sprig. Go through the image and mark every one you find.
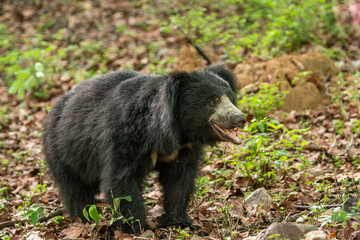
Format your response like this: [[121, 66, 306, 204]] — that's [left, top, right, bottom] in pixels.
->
[[103, 168, 148, 234]]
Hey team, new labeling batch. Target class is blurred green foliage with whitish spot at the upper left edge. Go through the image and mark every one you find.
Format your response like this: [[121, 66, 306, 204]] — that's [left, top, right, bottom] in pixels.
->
[[0, 24, 113, 99]]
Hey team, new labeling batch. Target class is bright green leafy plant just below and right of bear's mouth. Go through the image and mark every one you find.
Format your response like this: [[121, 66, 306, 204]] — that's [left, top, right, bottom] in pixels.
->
[[234, 119, 309, 181]]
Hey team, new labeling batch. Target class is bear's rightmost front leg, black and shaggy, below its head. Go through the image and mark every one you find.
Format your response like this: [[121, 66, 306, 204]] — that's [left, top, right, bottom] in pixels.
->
[[158, 146, 202, 227]]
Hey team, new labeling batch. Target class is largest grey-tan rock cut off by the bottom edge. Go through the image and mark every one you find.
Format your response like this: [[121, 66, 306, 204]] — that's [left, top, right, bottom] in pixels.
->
[[256, 223, 304, 240]]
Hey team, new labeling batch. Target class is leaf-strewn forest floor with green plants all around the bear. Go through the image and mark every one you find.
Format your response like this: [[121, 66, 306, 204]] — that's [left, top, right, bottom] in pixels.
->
[[0, 0, 360, 239]]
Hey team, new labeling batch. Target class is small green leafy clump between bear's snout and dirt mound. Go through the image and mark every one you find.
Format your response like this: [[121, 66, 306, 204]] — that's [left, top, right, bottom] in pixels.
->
[[238, 84, 287, 119]]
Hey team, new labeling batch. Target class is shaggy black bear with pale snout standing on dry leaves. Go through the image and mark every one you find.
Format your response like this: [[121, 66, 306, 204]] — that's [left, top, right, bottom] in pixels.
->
[[43, 64, 246, 233]]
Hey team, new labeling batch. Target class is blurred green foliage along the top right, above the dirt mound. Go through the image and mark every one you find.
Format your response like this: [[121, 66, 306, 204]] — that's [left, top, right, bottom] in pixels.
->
[[145, 0, 339, 62]]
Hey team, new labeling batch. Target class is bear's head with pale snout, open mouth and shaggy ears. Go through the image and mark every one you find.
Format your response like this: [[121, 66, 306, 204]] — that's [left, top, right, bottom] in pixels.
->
[[173, 65, 246, 144]]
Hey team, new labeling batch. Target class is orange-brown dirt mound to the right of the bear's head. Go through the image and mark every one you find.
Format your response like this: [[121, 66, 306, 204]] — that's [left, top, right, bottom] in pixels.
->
[[234, 53, 339, 111]]
